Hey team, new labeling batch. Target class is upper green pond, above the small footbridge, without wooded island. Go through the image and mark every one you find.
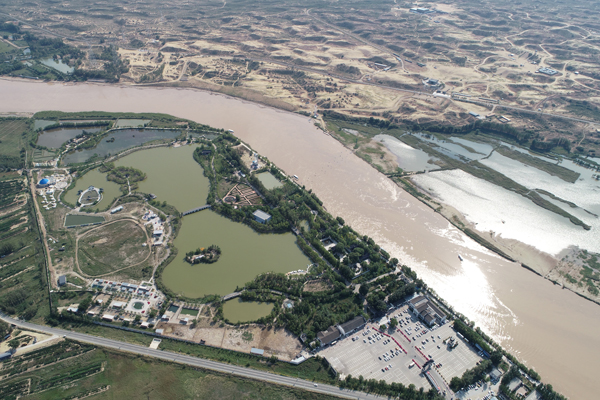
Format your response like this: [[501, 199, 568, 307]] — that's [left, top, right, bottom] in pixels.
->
[[115, 146, 209, 211]]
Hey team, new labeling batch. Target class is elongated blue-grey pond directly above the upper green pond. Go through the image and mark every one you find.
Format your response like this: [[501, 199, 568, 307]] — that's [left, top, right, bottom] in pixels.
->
[[63, 129, 181, 165]]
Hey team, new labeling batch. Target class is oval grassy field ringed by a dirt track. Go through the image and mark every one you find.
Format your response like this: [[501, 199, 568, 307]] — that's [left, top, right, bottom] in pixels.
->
[[78, 221, 151, 276]]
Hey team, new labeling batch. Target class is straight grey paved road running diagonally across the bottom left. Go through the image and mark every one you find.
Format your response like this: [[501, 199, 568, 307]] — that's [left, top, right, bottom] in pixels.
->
[[0, 315, 384, 400]]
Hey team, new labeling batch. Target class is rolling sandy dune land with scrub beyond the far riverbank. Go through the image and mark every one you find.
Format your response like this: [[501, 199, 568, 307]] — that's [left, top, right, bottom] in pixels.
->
[[5, 0, 600, 153]]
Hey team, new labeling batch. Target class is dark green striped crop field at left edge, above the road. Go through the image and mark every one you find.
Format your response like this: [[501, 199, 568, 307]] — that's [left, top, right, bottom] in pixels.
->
[[0, 177, 49, 320]]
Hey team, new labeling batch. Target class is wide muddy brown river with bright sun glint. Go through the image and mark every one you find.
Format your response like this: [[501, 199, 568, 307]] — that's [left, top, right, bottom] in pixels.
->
[[0, 80, 600, 399]]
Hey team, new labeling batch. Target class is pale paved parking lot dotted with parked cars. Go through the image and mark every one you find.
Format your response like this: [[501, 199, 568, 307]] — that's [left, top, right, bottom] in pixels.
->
[[319, 306, 481, 395]]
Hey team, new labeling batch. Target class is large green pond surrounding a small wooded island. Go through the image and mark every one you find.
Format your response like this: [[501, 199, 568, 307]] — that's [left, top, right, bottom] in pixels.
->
[[162, 210, 310, 298]]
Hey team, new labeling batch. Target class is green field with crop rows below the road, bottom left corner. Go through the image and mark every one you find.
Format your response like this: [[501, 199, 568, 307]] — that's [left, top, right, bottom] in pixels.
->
[[0, 341, 335, 400]]
